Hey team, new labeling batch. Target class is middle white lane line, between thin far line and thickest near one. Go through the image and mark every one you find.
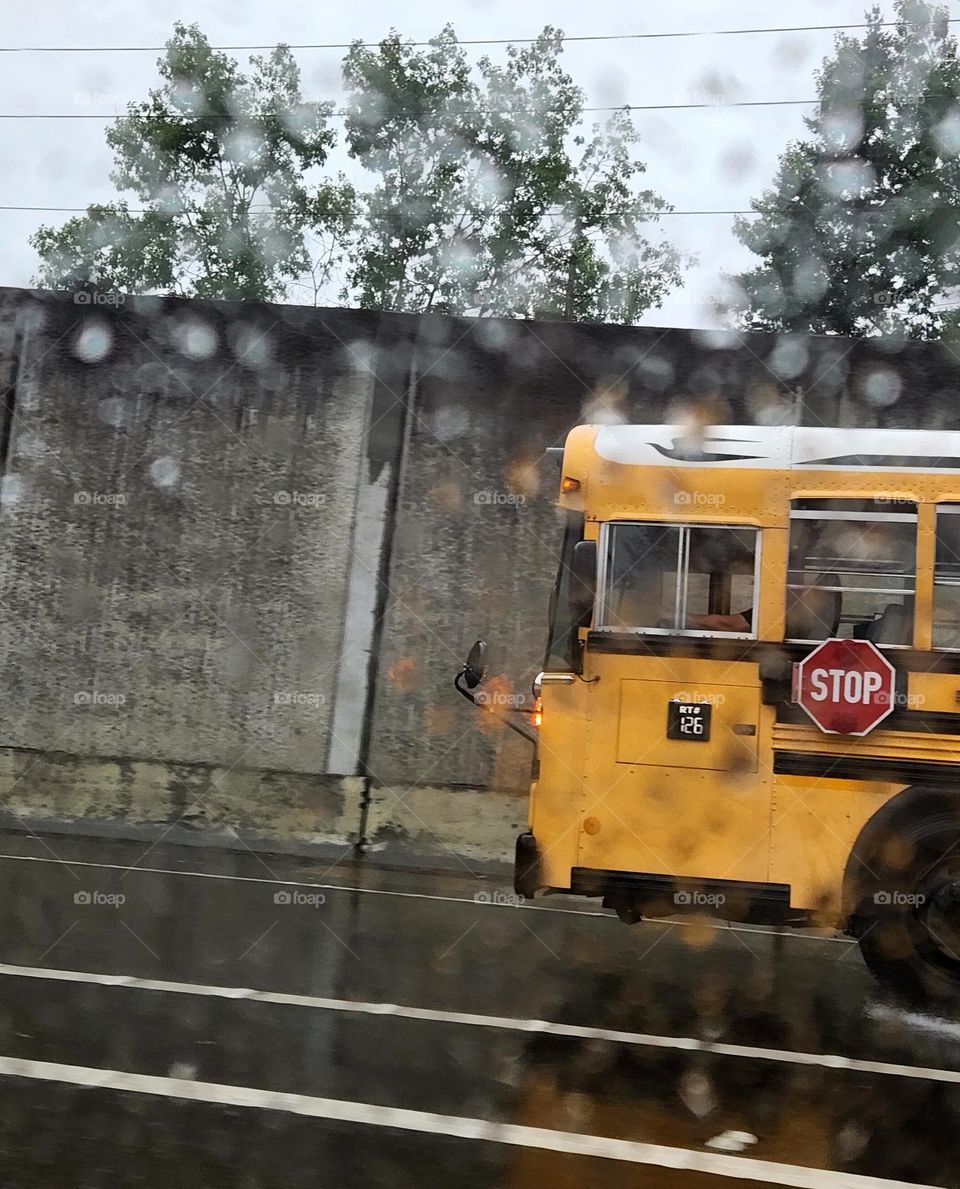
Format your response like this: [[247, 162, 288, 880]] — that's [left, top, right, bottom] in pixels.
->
[[0, 963, 960, 1083]]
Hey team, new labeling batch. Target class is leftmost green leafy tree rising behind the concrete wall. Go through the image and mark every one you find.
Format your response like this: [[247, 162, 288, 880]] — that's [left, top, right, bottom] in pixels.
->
[[31, 23, 353, 301]]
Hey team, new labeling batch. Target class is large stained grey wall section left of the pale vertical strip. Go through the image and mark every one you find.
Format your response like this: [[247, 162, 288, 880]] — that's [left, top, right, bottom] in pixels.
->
[[0, 297, 392, 773]]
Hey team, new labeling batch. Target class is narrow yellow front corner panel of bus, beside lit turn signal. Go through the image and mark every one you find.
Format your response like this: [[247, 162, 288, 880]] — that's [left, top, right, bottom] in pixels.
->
[[529, 681, 595, 888]]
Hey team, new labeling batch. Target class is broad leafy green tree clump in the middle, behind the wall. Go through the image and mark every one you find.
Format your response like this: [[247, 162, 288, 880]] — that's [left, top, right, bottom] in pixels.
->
[[344, 25, 683, 322]]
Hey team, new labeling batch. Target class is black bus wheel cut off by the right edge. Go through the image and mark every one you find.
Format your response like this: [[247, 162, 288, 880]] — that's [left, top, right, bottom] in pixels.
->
[[847, 788, 960, 1002]]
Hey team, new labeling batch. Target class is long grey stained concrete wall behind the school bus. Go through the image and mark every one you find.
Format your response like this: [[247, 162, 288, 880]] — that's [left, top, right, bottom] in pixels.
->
[[0, 290, 958, 862]]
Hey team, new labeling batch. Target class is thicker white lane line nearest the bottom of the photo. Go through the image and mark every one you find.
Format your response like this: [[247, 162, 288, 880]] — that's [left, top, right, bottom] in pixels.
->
[[0, 1057, 931, 1189]]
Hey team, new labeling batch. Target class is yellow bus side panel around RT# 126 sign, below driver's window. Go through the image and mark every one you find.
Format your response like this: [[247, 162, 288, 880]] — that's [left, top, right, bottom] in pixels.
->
[[577, 654, 771, 882]]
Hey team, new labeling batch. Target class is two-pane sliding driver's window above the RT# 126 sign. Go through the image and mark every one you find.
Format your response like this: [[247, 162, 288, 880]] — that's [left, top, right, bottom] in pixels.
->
[[598, 523, 758, 636]]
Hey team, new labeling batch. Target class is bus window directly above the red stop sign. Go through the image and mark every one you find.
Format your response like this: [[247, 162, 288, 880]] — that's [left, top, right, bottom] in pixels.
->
[[785, 499, 917, 647]]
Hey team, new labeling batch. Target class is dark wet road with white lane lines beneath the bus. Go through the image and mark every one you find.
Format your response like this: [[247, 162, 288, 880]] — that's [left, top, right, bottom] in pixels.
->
[[0, 835, 960, 1189]]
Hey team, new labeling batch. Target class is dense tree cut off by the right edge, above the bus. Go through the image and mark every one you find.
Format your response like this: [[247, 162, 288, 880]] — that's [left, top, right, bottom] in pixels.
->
[[735, 0, 960, 338]]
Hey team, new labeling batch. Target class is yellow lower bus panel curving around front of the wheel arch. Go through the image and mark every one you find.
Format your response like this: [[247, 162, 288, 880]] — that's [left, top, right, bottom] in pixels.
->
[[770, 776, 904, 925]]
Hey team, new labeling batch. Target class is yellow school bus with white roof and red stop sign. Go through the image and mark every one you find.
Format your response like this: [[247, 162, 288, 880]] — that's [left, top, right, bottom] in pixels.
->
[[460, 424, 960, 995]]
